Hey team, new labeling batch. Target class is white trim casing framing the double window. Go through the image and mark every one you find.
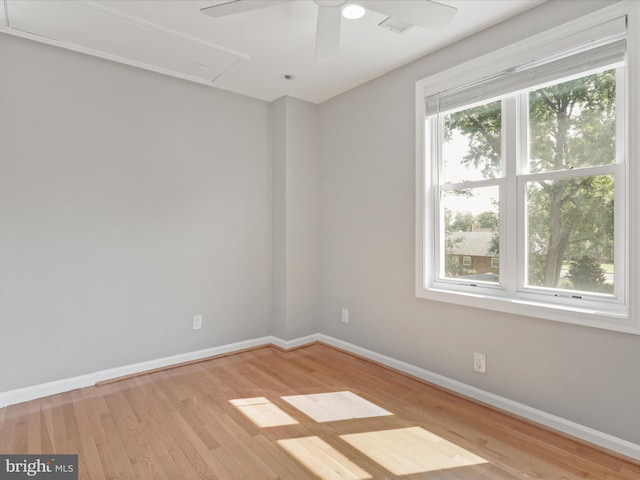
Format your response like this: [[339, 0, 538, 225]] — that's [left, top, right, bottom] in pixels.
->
[[415, 1, 640, 335]]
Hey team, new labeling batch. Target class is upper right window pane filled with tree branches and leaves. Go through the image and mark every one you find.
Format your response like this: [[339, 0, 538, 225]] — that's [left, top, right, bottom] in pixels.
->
[[529, 70, 616, 173]]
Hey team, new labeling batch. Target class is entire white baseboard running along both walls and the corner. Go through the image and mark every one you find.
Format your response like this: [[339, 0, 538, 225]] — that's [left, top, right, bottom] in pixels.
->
[[0, 333, 640, 461]]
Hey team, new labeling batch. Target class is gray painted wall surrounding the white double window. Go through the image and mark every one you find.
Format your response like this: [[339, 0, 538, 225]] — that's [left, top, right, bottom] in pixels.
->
[[319, 1, 640, 443]]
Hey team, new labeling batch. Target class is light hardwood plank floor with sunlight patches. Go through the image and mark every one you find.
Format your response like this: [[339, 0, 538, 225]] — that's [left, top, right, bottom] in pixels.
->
[[0, 345, 640, 480]]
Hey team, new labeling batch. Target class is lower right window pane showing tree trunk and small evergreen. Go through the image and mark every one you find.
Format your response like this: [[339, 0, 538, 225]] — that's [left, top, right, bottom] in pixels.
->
[[526, 175, 614, 293]]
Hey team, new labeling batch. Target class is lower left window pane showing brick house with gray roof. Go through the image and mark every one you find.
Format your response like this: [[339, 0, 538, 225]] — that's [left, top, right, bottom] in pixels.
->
[[441, 186, 500, 283]]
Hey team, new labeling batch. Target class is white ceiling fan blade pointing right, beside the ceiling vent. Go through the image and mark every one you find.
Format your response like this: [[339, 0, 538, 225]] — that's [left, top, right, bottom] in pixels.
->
[[363, 0, 458, 29]]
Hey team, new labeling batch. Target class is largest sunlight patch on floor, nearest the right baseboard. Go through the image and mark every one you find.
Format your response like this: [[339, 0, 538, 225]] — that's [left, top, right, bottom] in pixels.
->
[[340, 427, 489, 475]]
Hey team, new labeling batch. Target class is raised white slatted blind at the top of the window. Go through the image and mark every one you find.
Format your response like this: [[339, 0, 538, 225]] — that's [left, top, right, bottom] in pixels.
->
[[426, 17, 627, 115]]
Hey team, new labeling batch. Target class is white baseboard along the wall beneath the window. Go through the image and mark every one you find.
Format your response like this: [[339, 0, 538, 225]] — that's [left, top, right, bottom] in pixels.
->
[[318, 334, 640, 460]]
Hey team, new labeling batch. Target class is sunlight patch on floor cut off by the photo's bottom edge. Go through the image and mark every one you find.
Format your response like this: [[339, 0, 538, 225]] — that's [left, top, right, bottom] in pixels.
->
[[277, 437, 371, 480]]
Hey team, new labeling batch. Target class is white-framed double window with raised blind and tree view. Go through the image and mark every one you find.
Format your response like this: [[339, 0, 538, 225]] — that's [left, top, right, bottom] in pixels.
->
[[416, 10, 640, 333]]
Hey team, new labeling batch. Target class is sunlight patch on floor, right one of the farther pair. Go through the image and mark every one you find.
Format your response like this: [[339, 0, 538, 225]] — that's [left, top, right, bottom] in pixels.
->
[[282, 392, 393, 423]]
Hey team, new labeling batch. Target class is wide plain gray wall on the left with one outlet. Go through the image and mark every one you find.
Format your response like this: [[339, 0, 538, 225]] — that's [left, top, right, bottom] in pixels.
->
[[0, 34, 271, 391]]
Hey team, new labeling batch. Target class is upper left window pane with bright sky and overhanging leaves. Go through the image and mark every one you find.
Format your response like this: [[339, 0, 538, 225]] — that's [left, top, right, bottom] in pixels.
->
[[442, 101, 502, 183]]
